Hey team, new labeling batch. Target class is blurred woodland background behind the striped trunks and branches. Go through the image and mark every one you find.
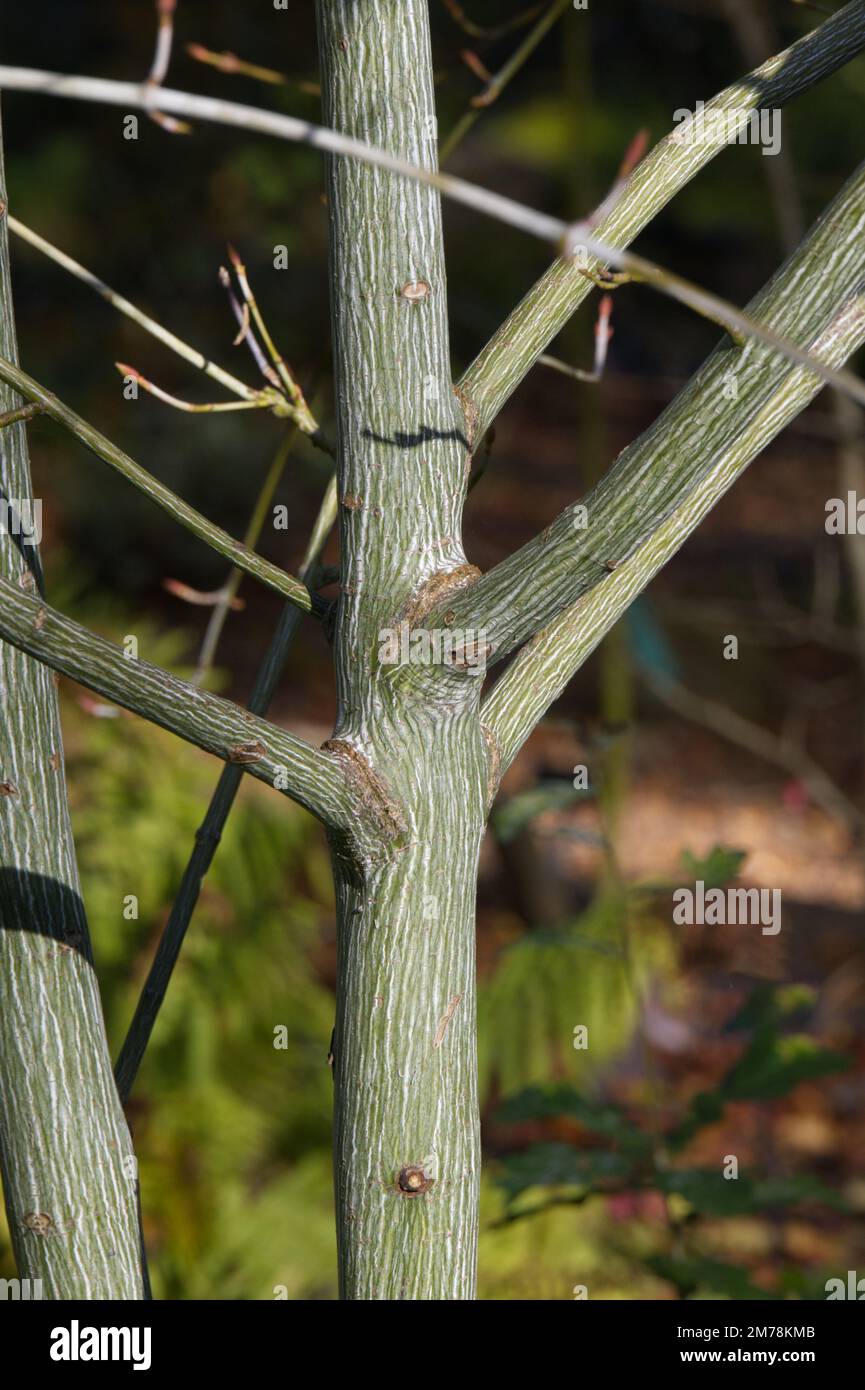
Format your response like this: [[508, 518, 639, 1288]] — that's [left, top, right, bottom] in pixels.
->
[[0, 0, 865, 1298]]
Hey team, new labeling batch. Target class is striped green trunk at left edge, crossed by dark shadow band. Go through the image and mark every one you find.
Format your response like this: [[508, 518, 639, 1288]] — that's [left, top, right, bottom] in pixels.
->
[[0, 108, 143, 1300]]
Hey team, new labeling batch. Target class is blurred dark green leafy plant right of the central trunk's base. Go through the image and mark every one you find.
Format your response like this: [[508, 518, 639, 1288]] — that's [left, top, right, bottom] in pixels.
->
[[496, 986, 850, 1300]]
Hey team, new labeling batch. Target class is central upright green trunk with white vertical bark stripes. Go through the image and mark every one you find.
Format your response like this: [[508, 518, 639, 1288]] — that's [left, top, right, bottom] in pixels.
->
[[317, 0, 488, 1300]]
